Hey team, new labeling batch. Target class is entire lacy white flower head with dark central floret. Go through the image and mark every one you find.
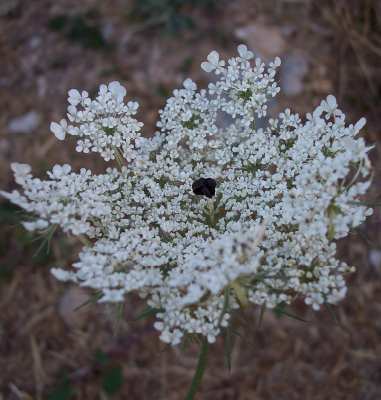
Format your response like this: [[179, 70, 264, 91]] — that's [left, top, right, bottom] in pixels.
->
[[1, 45, 372, 345]]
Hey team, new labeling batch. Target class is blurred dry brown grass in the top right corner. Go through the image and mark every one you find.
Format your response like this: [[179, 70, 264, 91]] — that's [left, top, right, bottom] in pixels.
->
[[311, 0, 381, 118]]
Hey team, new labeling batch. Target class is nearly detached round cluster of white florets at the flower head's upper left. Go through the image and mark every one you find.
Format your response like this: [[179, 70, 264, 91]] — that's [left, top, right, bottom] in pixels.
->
[[50, 82, 143, 161]]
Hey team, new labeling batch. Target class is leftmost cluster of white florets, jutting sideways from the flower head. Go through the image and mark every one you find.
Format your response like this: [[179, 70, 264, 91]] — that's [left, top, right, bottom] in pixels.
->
[[2, 163, 120, 238]]
